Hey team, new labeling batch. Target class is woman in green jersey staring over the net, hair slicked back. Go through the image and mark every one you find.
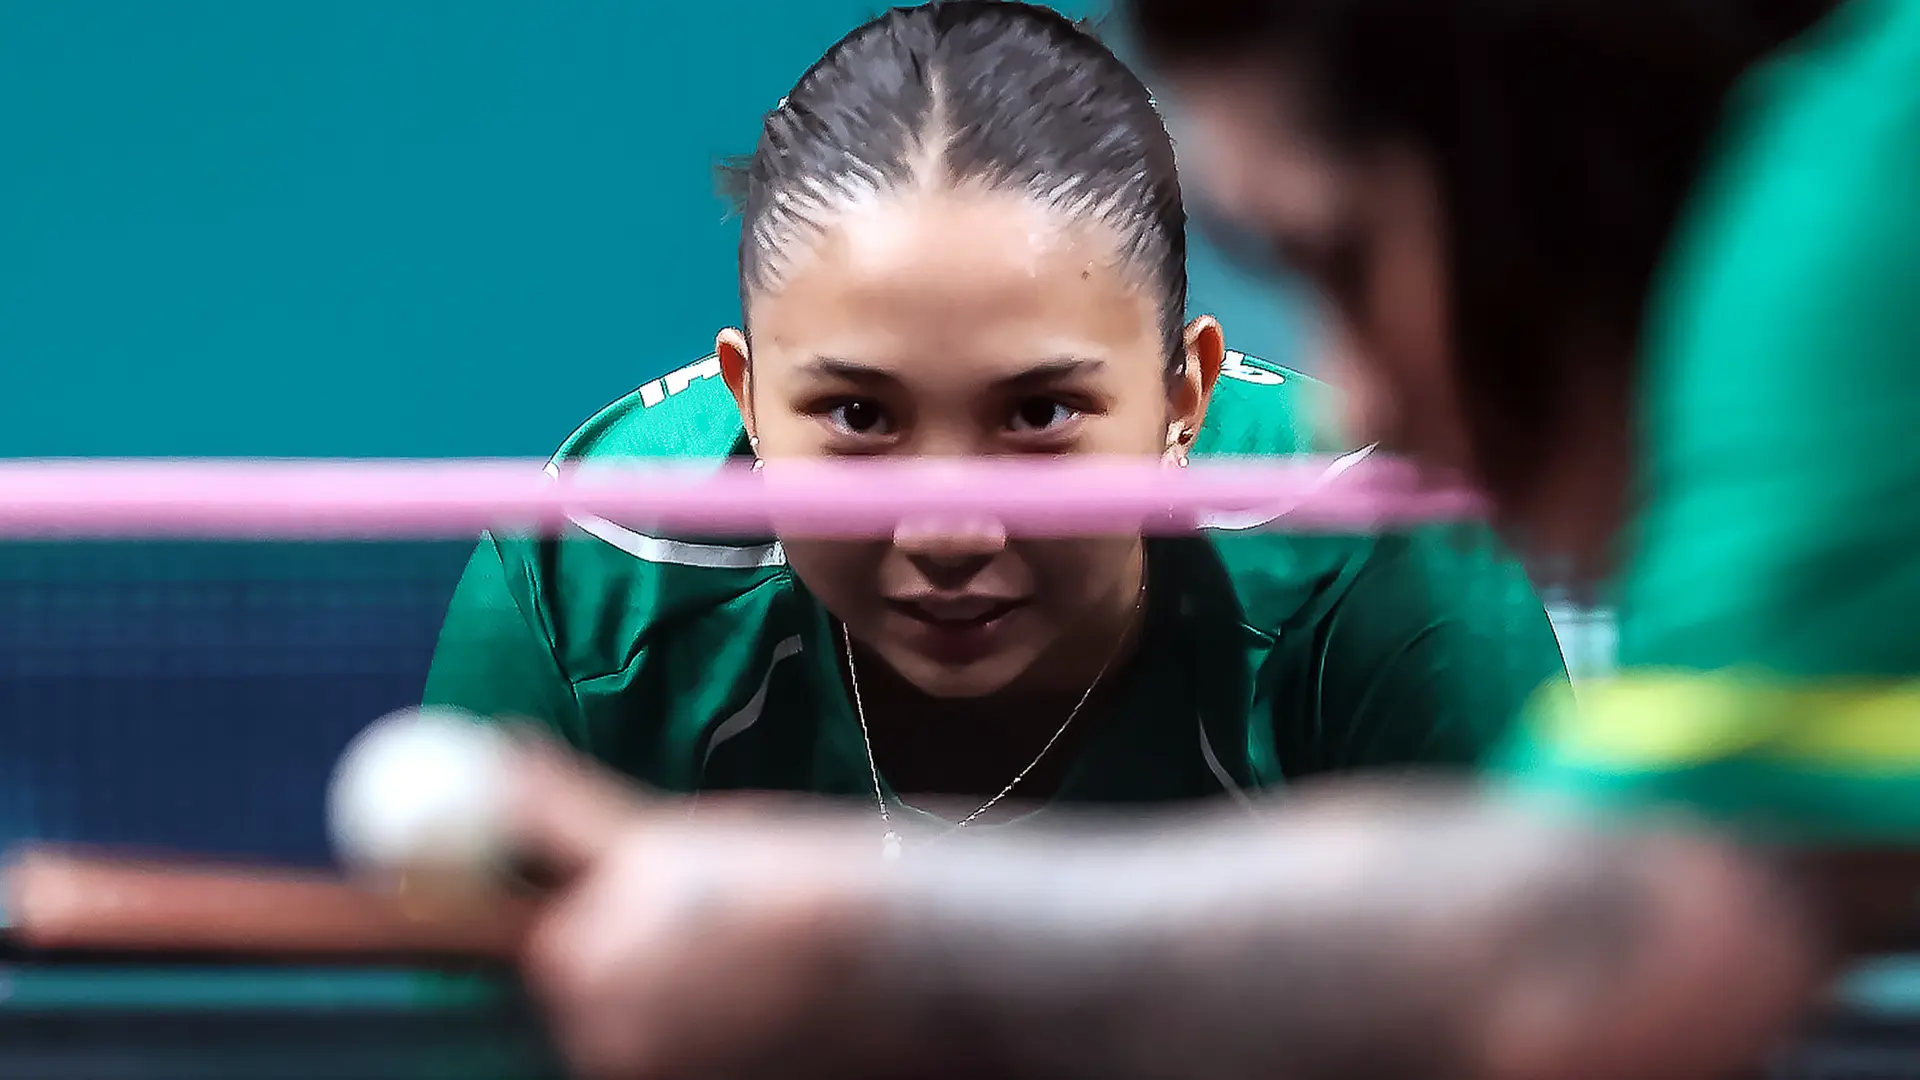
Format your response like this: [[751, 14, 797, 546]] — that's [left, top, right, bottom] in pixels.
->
[[426, 4, 1565, 834]]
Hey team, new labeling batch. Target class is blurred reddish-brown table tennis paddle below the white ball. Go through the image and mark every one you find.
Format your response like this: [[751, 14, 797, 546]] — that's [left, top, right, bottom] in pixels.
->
[[0, 847, 534, 961]]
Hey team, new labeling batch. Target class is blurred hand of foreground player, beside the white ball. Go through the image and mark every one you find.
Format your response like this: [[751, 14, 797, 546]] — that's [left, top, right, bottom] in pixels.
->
[[513, 746, 883, 1080]]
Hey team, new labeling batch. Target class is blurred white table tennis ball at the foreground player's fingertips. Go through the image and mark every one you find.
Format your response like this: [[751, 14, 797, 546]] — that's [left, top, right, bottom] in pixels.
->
[[326, 709, 513, 886]]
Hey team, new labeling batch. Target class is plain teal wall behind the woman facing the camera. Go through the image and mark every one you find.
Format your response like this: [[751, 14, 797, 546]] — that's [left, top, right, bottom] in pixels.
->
[[0, 0, 1288, 457]]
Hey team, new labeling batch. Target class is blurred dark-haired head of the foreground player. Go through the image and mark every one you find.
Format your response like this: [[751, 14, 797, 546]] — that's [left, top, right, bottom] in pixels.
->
[[1131, 0, 1834, 572]]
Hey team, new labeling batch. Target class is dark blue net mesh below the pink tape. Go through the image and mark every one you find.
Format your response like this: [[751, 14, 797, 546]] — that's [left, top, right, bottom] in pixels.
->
[[0, 538, 1611, 863]]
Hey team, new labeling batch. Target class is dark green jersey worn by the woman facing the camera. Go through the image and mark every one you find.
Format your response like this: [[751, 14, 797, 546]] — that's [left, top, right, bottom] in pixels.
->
[[426, 354, 1563, 803]]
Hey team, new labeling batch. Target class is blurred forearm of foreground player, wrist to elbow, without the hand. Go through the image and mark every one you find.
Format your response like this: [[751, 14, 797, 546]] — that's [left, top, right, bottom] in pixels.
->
[[851, 790, 1820, 1080]]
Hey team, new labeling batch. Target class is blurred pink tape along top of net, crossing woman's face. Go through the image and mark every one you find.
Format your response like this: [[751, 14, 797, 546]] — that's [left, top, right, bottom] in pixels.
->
[[0, 454, 1480, 538]]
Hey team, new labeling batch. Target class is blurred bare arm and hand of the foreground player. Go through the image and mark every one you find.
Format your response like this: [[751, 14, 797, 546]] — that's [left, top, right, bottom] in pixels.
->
[[495, 734, 1820, 1080]]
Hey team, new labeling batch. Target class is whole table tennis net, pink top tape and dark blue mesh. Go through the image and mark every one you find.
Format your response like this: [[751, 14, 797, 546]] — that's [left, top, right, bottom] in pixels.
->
[[0, 441, 1611, 863]]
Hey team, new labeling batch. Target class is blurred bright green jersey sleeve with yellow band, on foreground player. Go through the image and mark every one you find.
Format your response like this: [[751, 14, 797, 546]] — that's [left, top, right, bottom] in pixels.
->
[[1515, 0, 1920, 844]]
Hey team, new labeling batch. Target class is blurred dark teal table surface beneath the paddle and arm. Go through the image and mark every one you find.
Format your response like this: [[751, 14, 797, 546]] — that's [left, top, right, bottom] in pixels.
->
[[11, 957, 1920, 1080]]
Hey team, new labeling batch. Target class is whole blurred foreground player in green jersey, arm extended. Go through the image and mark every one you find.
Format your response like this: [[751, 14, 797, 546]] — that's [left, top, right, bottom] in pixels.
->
[[476, 0, 1920, 1078]]
